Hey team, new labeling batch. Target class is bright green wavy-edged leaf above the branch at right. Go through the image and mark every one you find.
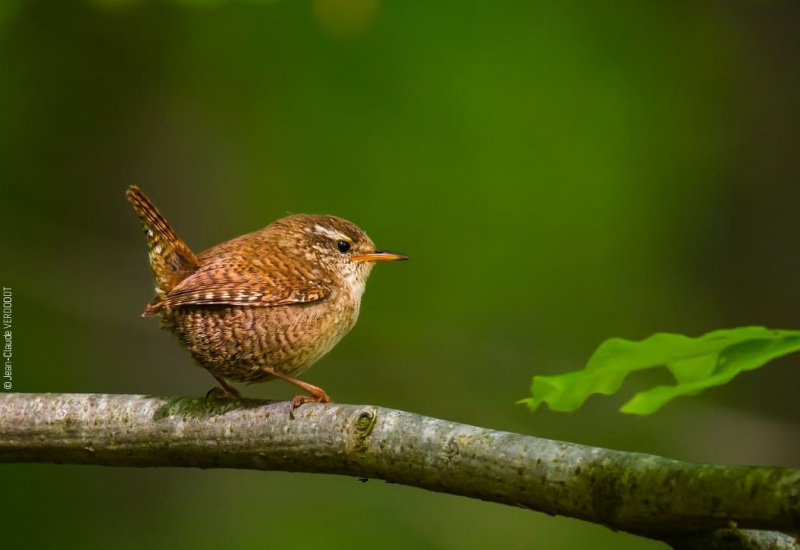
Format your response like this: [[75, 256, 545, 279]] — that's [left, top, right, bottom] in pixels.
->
[[518, 327, 800, 414]]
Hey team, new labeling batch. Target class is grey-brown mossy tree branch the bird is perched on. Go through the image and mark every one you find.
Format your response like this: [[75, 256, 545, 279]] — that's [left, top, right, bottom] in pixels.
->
[[0, 394, 800, 549]]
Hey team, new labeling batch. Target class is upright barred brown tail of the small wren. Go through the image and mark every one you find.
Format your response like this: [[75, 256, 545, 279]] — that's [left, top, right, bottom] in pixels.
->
[[125, 185, 198, 316]]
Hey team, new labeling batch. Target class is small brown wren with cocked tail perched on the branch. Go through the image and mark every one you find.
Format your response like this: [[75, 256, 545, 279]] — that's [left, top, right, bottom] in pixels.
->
[[126, 186, 408, 409]]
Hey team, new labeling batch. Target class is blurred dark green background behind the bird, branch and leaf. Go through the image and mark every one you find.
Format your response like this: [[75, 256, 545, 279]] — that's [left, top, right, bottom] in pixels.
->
[[0, 0, 800, 549]]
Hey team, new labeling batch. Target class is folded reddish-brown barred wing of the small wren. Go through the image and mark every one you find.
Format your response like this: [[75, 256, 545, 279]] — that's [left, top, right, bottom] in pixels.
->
[[144, 259, 332, 316]]
